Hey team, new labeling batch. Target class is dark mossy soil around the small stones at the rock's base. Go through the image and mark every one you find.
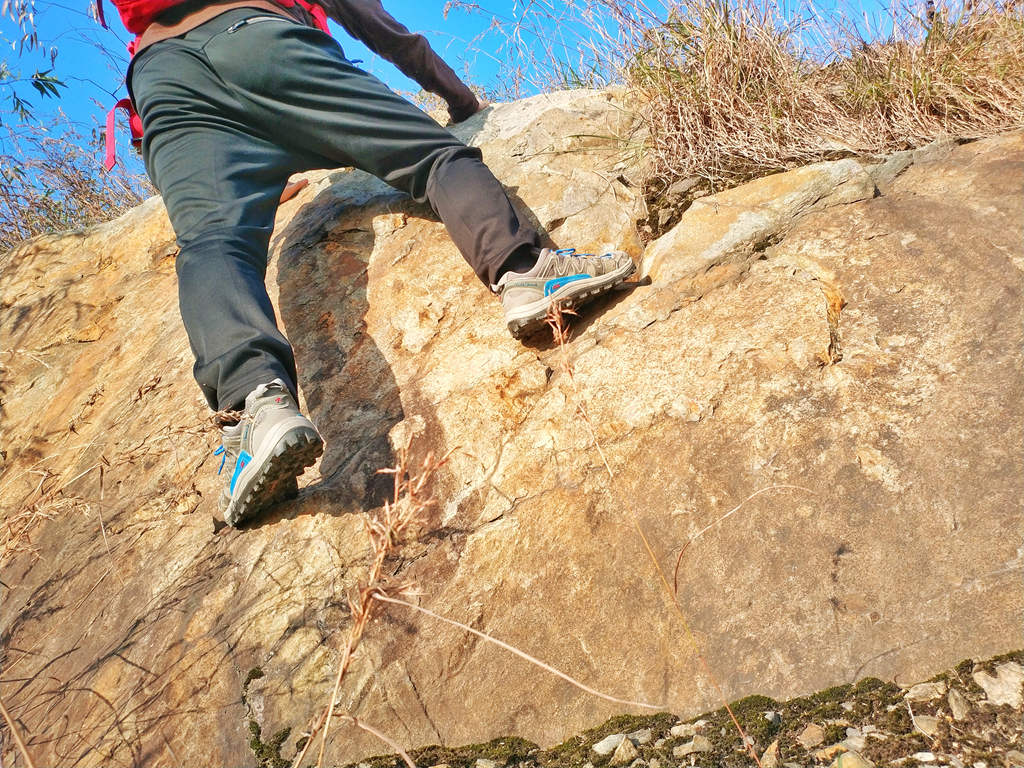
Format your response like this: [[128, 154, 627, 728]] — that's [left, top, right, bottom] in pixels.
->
[[250, 650, 1024, 768]]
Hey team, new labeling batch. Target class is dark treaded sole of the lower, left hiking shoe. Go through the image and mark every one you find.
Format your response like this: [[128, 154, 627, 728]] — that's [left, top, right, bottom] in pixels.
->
[[224, 426, 324, 527]]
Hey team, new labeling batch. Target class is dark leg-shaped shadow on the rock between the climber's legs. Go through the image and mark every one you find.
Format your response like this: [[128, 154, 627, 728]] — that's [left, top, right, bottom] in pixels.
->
[[276, 195, 404, 514]]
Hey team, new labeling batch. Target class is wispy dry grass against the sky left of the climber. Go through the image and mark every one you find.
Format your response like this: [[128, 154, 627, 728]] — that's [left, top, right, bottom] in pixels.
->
[[0, 121, 154, 253]]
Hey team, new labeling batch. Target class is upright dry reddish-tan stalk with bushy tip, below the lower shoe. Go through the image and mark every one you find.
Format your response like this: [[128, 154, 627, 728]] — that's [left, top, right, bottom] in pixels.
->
[[293, 437, 452, 768]]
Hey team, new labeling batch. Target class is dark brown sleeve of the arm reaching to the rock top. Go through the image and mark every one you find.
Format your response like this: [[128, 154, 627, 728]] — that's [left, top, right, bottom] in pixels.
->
[[321, 0, 478, 122]]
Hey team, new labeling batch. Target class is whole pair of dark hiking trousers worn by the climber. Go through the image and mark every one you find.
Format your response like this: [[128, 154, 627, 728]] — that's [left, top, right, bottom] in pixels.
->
[[129, 8, 538, 409]]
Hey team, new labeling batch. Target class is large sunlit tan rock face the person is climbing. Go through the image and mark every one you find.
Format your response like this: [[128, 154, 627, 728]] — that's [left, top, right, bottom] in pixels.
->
[[0, 92, 1024, 766]]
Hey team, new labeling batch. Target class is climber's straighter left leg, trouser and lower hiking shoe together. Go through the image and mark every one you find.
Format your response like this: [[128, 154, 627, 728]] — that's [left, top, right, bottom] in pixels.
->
[[129, 13, 324, 525]]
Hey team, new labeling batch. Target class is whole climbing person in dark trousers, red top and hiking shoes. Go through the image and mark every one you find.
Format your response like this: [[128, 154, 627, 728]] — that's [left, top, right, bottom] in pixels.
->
[[98, 0, 634, 525]]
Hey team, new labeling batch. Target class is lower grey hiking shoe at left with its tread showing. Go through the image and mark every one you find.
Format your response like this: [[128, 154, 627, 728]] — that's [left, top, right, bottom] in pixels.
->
[[216, 379, 324, 525]]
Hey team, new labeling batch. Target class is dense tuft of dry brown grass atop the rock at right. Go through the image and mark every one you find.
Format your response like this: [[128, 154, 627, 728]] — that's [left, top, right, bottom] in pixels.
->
[[627, 2, 1024, 188]]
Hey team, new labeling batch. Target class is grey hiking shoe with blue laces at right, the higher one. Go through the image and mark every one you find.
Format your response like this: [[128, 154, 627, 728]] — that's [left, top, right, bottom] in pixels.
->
[[495, 248, 636, 339]]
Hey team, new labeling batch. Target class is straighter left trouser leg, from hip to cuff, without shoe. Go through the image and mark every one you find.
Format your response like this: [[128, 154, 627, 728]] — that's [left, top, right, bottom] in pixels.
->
[[131, 30, 296, 410]]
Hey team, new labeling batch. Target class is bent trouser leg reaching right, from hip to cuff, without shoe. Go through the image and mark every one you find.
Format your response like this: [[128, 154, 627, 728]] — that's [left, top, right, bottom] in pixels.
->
[[194, 11, 538, 285]]
